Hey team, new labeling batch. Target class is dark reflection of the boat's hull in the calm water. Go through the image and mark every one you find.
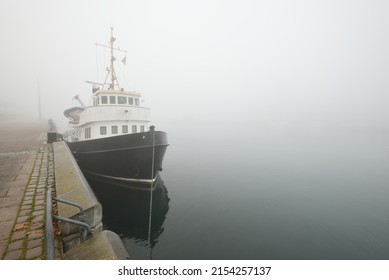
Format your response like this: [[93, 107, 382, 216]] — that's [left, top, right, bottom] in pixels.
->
[[85, 174, 170, 259]]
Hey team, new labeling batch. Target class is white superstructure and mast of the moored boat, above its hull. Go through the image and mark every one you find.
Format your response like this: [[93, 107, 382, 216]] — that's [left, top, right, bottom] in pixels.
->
[[65, 29, 150, 142]]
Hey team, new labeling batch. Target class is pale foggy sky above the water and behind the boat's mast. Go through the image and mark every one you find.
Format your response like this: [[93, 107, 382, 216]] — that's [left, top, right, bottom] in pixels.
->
[[0, 0, 389, 133]]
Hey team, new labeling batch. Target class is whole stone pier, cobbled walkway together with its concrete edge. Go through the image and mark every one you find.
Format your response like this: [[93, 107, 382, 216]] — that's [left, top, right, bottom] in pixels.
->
[[0, 121, 129, 260]]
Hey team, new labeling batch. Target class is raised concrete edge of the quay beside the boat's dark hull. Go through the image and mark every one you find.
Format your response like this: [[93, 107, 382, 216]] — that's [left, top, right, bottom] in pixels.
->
[[53, 141, 130, 260]]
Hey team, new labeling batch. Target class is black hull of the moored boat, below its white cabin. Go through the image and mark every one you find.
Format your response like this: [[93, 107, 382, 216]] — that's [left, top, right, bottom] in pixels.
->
[[68, 131, 168, 188]]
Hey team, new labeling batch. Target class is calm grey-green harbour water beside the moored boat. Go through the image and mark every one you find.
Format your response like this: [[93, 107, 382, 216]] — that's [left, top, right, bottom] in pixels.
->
[[87, 124, 389, 259]]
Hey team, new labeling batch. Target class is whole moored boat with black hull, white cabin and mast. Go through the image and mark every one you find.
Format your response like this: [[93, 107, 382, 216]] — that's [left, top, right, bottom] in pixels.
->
[[64, 28, 169, 190]]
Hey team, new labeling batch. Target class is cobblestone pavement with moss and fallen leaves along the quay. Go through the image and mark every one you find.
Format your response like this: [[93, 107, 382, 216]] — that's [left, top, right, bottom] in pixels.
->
[[0, 123, 54, 260]]
